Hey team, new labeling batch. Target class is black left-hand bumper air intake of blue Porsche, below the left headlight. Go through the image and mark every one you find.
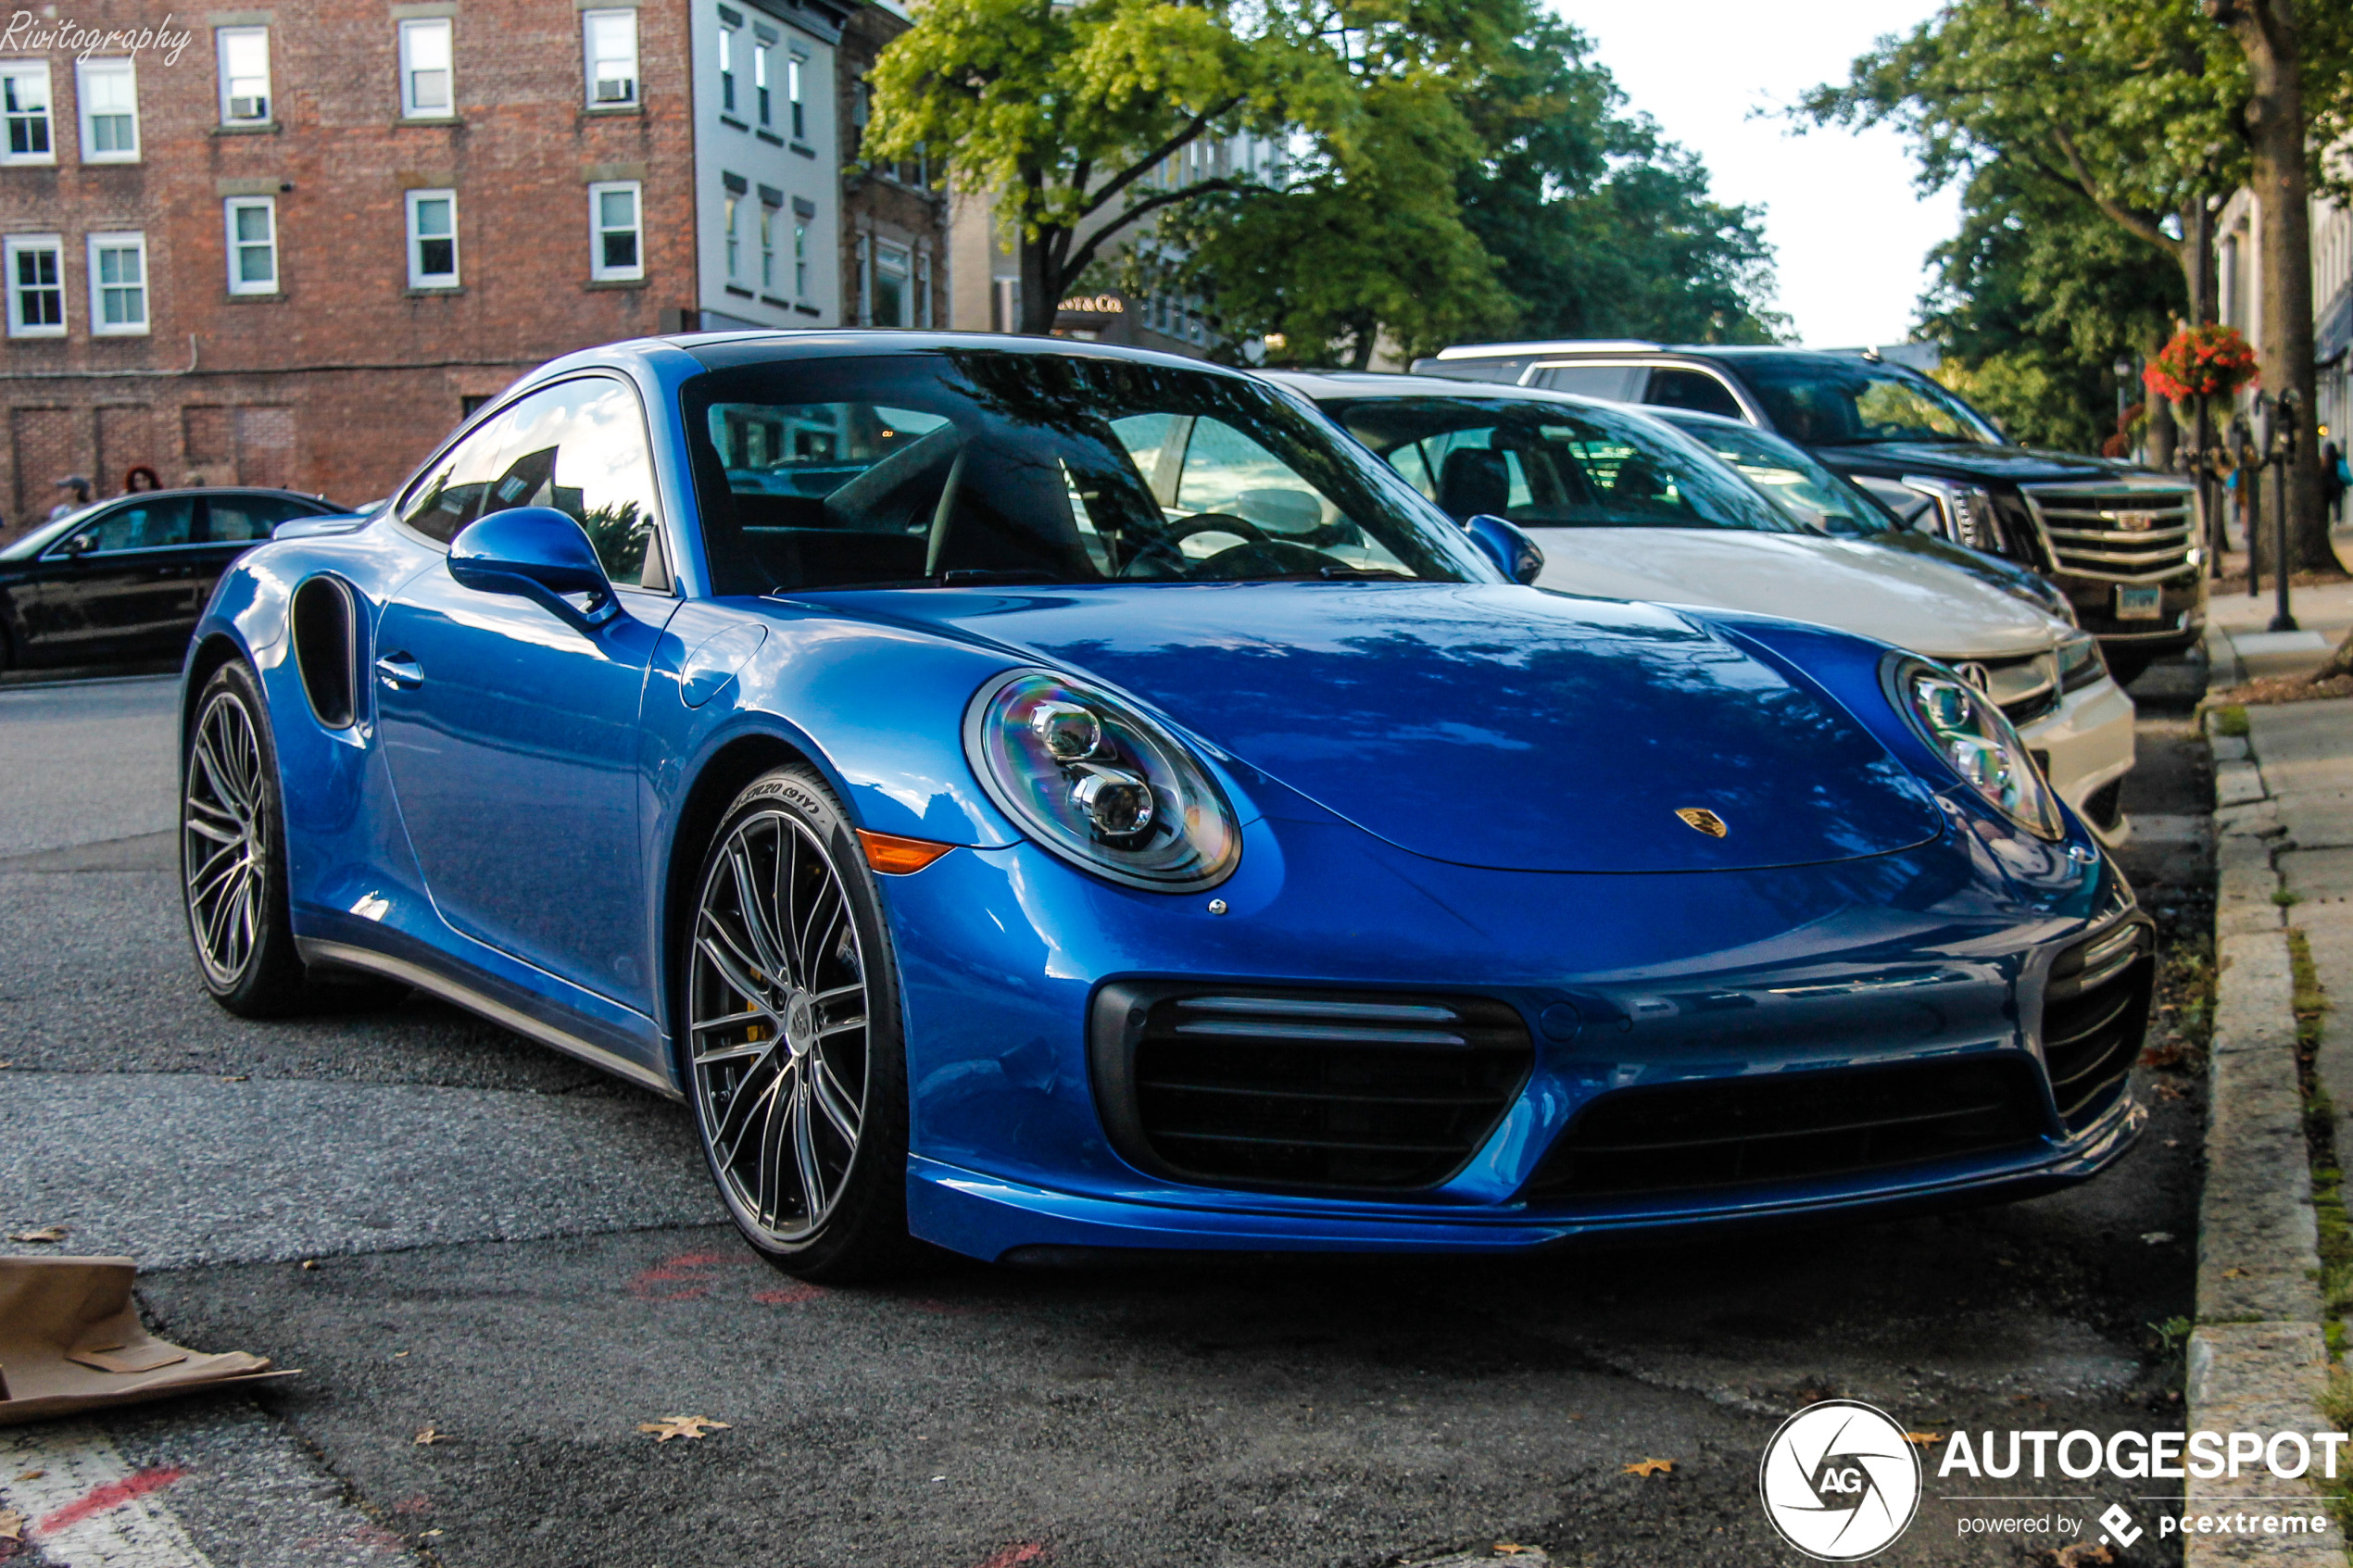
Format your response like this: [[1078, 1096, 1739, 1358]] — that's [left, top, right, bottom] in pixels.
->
[[1089, 985, 1534, 1192]]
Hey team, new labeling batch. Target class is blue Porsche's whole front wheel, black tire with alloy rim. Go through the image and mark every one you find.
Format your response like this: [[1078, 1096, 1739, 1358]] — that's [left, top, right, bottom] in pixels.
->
[[678, 766, 923, 1281]]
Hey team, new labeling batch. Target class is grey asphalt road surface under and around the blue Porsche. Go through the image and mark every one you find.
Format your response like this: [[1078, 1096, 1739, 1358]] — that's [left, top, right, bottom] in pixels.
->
[[0, 667, 2209, 1568]]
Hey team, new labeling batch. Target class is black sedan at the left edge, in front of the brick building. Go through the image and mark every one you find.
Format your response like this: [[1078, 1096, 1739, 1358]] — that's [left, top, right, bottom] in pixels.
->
[[0, 489, 344, 670]]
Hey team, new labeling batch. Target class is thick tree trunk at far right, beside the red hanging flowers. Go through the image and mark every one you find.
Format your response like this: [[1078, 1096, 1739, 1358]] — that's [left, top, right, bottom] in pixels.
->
[[2221, 0, 2346, 576]]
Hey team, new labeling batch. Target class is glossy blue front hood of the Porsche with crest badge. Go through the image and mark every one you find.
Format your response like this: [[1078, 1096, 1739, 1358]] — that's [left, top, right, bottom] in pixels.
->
[[836, 583, 1942, 872]]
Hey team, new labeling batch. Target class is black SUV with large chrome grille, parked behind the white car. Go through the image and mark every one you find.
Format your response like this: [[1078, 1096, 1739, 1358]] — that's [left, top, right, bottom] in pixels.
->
[[1415, 341, 2205, 682]]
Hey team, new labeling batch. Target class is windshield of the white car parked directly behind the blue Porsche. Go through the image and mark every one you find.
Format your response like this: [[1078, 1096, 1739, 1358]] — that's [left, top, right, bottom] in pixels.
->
[[1325, 395, 1805, 533]]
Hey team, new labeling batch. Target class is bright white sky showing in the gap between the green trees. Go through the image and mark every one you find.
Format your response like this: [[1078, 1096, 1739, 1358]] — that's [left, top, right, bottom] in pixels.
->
[[1553, 0, 1957, 348]]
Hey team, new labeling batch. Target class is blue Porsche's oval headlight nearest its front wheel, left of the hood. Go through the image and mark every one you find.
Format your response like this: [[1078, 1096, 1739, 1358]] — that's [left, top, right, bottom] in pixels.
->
[[964, 670, 1242, 894]]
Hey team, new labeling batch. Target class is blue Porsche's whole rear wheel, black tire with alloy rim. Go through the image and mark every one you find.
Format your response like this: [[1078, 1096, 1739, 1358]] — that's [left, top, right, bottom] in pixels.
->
[[179, 660, 409, 1018]]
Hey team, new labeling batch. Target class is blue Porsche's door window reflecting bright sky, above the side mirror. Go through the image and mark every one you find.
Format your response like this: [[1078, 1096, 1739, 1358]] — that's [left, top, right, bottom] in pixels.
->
[[483, 376, 668, 590]]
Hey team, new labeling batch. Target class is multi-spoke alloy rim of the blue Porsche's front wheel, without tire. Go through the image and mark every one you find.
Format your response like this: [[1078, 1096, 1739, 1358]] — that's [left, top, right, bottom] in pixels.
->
[[689, 811, 868, 1246]]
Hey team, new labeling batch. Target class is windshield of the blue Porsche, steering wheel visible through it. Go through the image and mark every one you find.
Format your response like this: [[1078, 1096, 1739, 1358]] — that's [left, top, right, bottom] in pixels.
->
[[683, 350, 1491, 593]]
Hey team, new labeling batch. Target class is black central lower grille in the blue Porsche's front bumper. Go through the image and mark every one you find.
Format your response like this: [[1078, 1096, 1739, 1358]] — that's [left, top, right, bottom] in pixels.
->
[[1522, 1058, 2040, 1198]]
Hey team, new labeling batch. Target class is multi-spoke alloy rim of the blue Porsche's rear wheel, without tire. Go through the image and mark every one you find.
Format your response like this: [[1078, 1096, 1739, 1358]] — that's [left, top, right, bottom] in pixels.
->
[[179, 691, 266, 987]]
